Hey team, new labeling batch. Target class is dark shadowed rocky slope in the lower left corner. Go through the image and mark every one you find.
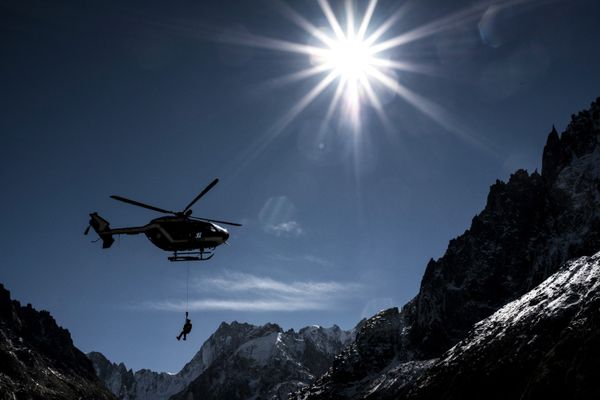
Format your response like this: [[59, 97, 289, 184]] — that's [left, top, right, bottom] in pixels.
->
[[0, 284, 114, 399]]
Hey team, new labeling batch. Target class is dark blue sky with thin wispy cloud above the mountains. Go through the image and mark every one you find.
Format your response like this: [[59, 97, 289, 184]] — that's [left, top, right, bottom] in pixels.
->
[[0, 0, 600, 372]]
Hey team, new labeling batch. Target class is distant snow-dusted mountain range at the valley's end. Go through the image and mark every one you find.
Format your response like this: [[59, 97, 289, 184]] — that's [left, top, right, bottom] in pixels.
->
[[88, 321, 352, 400]]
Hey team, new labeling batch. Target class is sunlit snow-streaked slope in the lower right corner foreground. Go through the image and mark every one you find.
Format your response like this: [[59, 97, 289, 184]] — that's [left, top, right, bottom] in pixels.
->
[[398, 253, 600, 400]]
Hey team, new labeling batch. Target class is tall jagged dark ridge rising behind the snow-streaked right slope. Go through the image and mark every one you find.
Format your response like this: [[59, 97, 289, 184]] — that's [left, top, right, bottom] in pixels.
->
[[291, 99, 600, 399]]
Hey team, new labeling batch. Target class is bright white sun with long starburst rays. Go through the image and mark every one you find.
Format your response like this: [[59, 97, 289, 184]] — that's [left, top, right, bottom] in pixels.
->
[[223, 0, 482, 136]]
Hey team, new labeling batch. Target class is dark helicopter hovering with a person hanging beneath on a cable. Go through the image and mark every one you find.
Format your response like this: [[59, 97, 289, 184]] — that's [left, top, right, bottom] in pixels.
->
[[84, 179, 242, 261]]
